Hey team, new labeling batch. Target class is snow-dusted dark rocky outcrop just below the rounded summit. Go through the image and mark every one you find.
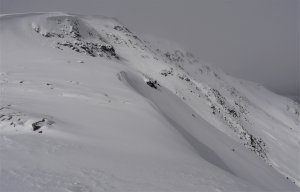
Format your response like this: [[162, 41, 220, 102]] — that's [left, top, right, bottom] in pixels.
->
[[32, 16, 118, 58]]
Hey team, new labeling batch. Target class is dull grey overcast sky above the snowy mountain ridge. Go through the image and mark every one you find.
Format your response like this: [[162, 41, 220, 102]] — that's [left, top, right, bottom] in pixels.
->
[[0, 0, 300, 95]]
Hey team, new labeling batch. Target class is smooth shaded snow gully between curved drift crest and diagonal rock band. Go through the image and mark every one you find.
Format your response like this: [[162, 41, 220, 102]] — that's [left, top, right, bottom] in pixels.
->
[[120, 72, 298, 190]]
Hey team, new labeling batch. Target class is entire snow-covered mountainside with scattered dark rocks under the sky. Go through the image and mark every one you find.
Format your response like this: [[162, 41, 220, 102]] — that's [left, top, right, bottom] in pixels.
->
[[0, 13, 300, 192]]
